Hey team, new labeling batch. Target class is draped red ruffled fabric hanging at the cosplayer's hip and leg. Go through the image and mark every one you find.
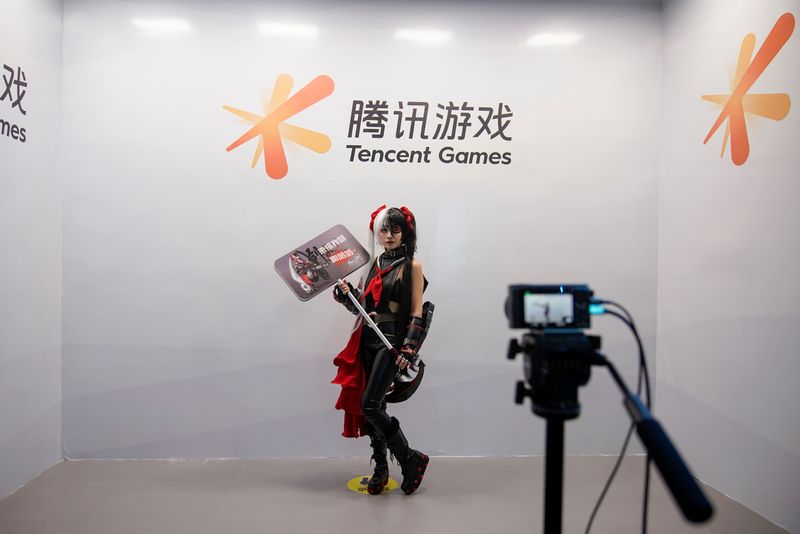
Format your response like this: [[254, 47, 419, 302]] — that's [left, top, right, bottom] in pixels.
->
[[331, 325, 366, 438]]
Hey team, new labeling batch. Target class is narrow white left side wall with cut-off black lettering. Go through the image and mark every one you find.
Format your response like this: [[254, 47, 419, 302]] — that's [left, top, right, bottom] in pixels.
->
[[0, 0, 61, 497]]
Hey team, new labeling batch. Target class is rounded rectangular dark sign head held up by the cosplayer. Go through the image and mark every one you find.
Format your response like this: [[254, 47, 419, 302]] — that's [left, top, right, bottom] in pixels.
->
[[275, 224, 369, 301]]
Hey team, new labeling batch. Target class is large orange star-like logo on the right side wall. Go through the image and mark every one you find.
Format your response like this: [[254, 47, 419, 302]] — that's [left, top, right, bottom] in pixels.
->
[[703, 13, 794, 165]]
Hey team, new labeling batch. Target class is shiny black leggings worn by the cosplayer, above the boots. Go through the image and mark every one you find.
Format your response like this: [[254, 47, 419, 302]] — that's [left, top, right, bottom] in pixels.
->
[[361, 323, 398, 438]]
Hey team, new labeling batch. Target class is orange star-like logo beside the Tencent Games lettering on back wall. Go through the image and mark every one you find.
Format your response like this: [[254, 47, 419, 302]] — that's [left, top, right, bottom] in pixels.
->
[[222, 74, 333, 180]]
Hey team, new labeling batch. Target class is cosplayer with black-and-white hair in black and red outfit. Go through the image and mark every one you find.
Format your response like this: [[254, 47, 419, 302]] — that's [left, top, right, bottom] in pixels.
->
[[333, 206, 429, 495]]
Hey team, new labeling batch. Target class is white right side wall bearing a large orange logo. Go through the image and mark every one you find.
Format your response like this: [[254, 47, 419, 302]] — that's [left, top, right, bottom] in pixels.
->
[[657, 0, 800, 532]]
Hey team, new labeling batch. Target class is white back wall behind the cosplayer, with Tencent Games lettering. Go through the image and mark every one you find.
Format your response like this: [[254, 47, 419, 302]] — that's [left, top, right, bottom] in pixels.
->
[[63, 0, 661, 458]]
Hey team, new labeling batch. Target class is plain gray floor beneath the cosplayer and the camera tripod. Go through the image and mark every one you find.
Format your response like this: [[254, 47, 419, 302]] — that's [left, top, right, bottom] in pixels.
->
[[0, 456, 785, 534]]
